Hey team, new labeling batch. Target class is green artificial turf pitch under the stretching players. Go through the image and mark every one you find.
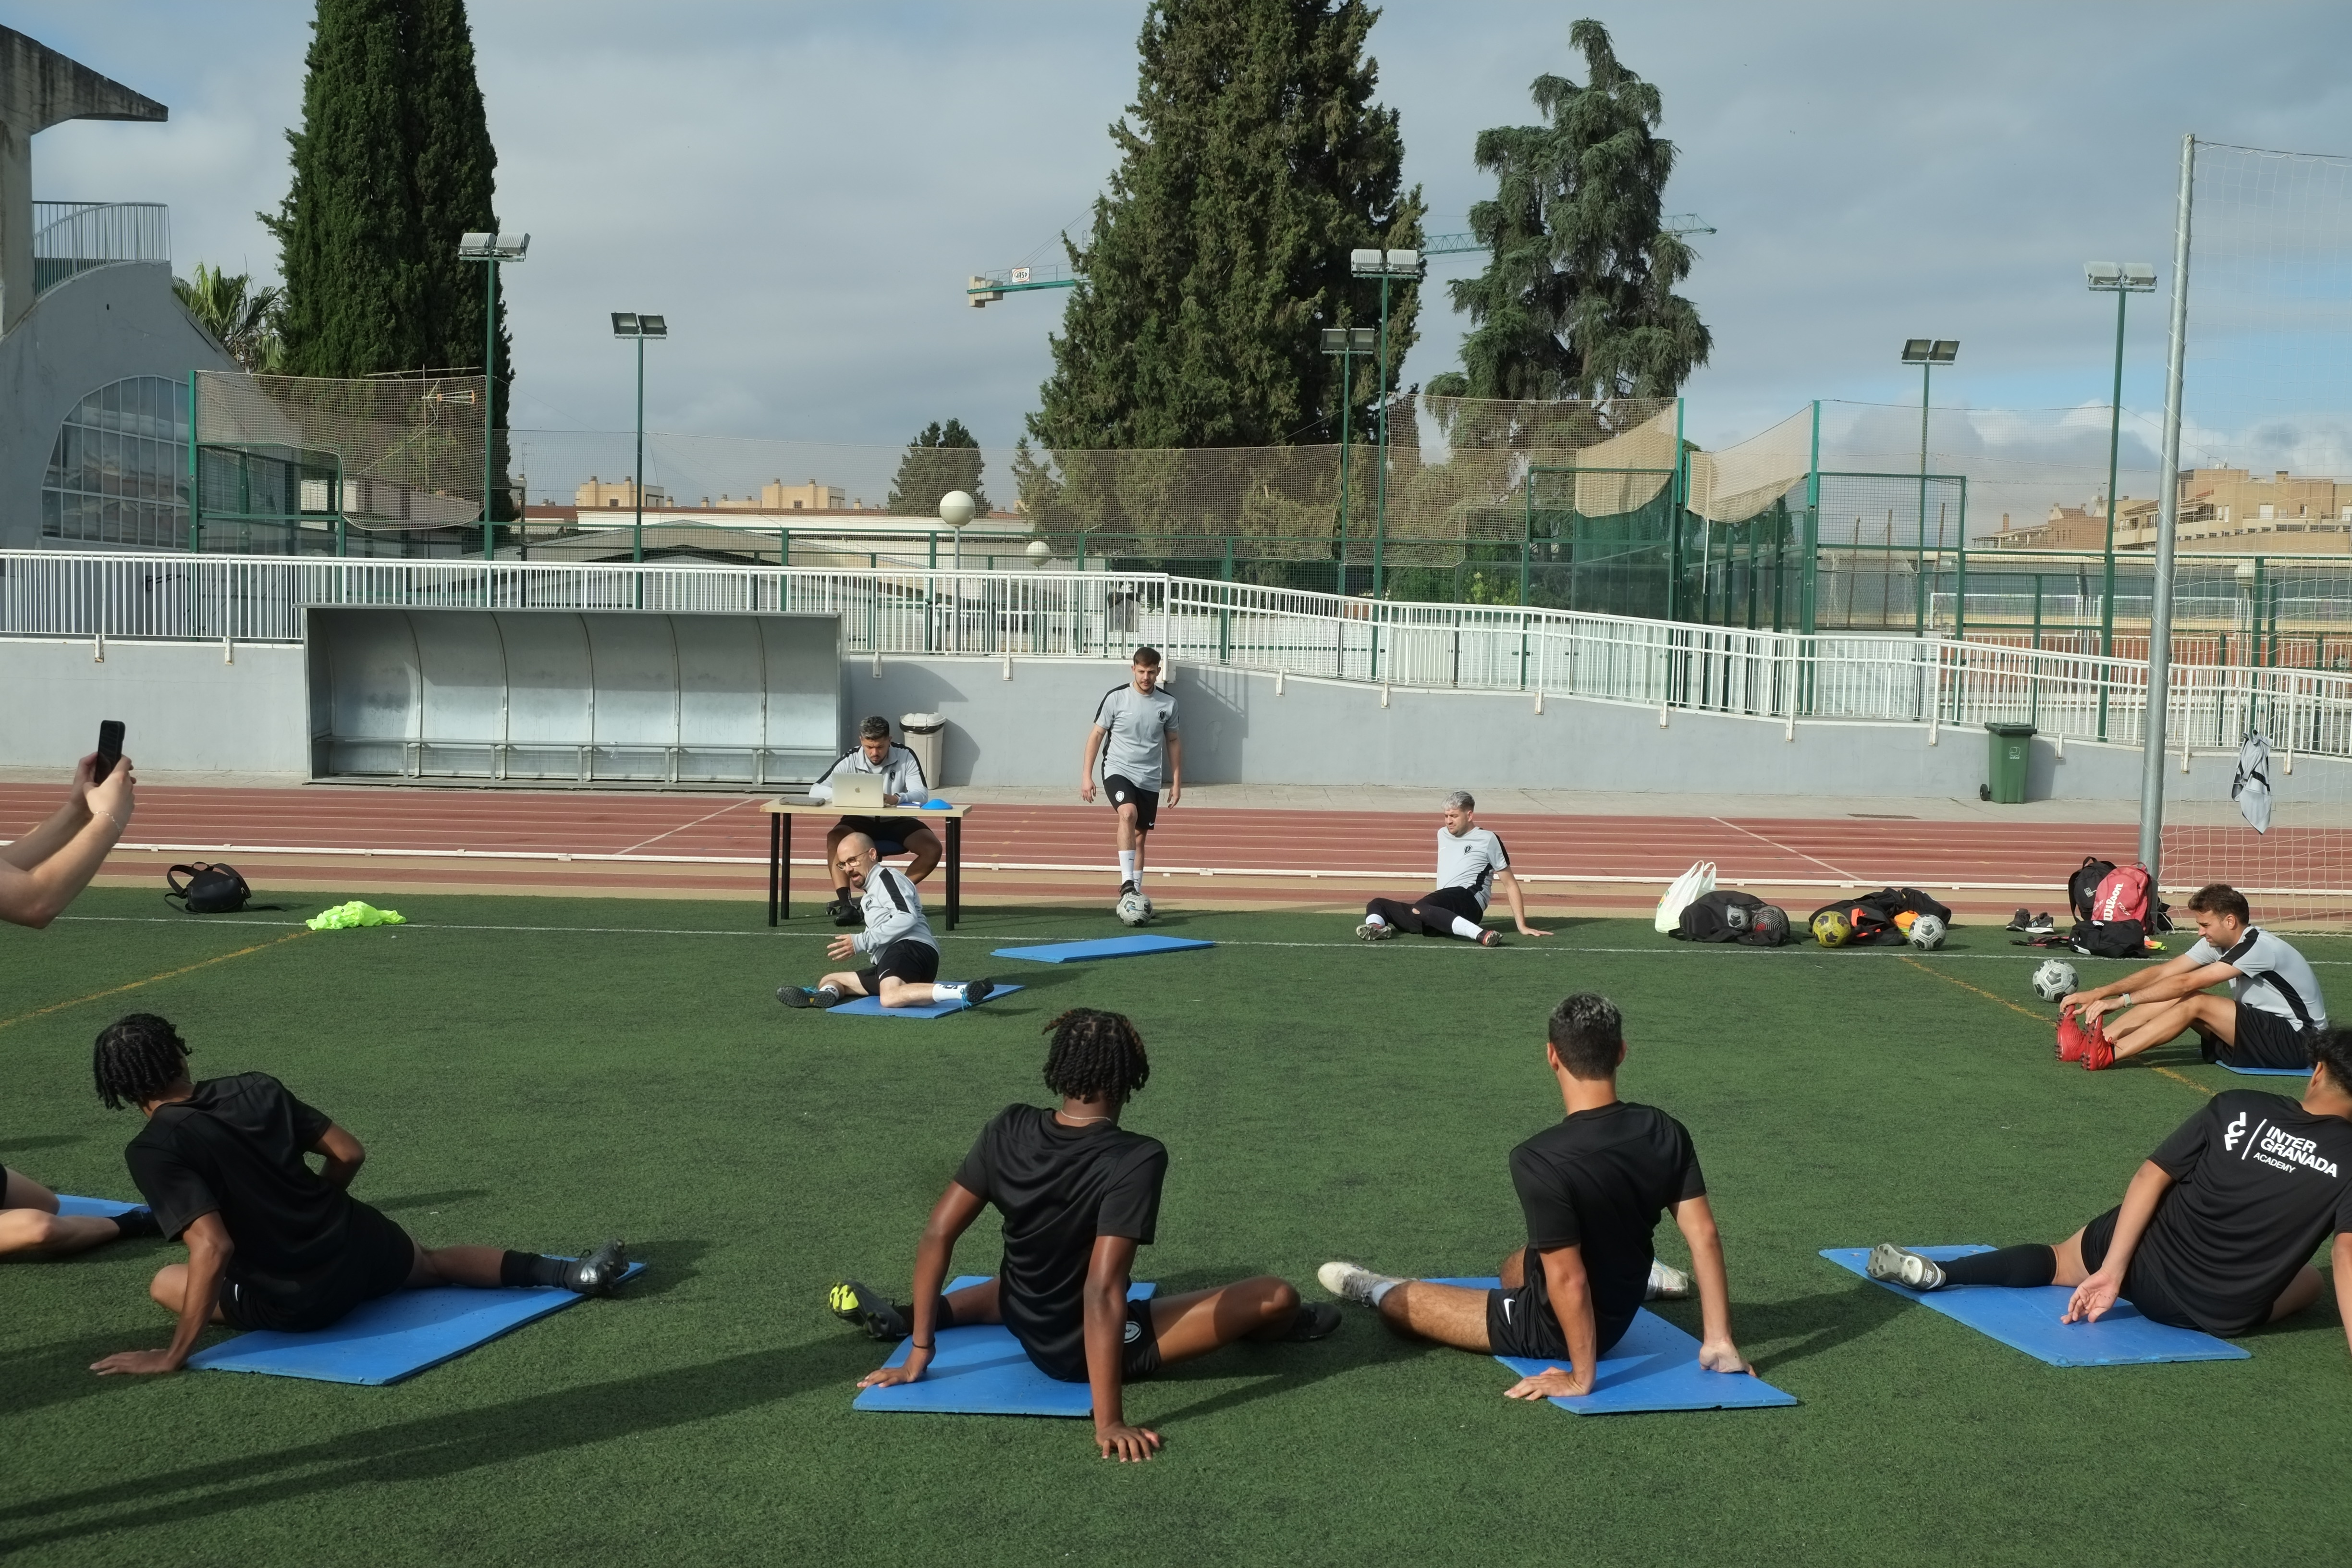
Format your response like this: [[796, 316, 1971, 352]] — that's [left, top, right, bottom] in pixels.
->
[[0, 891, 2352, 1568]]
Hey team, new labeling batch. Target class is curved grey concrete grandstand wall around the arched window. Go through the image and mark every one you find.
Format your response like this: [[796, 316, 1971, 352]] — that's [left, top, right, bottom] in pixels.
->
[[0, 261, 237, 550]]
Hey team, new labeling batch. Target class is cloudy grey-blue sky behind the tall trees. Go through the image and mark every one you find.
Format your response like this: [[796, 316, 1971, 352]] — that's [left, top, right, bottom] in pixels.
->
[[23, 0, 2352, 514]]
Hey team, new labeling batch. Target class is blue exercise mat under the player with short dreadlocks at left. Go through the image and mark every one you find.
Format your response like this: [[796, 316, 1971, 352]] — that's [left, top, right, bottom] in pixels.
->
[[188, 1262, 645, 1387]]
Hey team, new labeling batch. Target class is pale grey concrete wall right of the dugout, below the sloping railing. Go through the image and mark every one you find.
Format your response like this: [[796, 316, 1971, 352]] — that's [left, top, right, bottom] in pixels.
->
[[842, 658, 2295, 799]]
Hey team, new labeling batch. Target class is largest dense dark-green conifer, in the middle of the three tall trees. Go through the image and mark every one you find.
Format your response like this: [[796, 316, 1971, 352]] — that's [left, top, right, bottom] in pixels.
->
[[1028, 0, 1423, 452]]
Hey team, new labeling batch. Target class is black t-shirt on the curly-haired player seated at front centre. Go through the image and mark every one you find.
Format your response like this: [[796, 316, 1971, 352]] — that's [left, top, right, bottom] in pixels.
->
[[955, 1105, 1169, 1380]]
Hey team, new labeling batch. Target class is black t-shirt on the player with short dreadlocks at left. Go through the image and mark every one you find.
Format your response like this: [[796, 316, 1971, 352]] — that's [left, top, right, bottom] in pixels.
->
[[122, 1072, 351, 1279]]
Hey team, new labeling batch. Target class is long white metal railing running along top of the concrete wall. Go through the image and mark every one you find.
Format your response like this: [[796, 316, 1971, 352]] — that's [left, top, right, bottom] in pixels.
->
[[13, 550, 2352, 757]]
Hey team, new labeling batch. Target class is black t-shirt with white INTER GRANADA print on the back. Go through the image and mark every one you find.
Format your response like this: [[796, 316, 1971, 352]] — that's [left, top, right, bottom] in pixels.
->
[[2131, 1089, 2352, 1333]]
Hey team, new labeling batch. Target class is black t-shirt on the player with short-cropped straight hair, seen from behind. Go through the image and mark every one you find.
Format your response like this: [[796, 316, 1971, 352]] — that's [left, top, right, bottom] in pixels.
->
[[1510, 1100, 1707, 1321]]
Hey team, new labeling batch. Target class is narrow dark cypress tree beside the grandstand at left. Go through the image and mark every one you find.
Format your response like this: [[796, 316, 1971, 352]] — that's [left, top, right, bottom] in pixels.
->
[[261, 0, 513, 451]]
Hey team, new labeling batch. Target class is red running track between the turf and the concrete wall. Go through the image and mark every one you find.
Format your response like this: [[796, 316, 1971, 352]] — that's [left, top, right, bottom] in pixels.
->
[[0, 785, 2182, 889]]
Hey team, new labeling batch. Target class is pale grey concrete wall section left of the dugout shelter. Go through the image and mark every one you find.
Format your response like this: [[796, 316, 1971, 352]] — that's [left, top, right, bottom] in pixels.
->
[[0, 637, 310, 778]]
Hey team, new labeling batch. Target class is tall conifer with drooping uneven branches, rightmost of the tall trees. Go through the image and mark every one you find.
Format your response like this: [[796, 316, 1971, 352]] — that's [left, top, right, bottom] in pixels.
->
[[1430, 19, 1712, 400]]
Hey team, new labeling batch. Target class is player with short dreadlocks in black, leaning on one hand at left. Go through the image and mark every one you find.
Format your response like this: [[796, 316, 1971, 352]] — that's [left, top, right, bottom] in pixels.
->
[[89, 1013, 628, 1373]]
